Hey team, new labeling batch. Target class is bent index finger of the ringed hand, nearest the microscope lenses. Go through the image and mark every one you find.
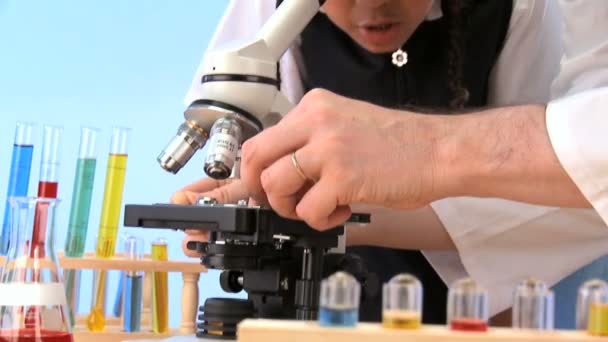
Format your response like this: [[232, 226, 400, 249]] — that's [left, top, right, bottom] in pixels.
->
[[241, 115, 311, 201]]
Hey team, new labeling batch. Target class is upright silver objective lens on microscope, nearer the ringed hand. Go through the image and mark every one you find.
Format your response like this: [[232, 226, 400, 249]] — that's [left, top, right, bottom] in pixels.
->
[[205, 117, 243, 179]]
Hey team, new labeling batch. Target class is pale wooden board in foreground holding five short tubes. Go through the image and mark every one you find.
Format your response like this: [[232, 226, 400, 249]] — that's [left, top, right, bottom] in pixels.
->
[[238, 320, 608, 342]]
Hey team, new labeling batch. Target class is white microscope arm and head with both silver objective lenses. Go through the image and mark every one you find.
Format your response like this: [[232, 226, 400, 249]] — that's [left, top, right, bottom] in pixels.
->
[[158, 0, 324, 179]]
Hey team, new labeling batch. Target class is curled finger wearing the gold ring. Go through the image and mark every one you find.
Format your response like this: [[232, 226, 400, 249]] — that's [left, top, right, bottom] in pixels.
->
[[261, 145, 320, 218]]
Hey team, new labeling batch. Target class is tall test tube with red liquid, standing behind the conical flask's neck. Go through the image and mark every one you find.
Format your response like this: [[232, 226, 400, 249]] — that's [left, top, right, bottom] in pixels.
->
[[31, 126, 62, 257]]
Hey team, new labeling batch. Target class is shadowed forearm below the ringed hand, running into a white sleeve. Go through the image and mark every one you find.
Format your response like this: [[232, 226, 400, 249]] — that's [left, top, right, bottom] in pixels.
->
[[346, 205, 455, 250]]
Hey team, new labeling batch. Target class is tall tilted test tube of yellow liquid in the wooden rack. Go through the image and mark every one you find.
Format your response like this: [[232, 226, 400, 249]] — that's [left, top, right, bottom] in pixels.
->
[[87, 127, 129, 331]]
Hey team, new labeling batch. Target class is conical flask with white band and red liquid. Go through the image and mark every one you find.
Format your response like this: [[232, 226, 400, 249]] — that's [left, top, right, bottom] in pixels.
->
[[0, 197, 73, 342]]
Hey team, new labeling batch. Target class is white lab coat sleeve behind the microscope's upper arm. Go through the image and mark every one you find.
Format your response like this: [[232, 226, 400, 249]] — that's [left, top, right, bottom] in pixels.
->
[[184, 0, 302, 106]]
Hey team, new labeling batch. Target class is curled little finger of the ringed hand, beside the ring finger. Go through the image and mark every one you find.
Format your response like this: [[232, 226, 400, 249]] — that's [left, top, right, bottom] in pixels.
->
[[296, 178, 351, 230]]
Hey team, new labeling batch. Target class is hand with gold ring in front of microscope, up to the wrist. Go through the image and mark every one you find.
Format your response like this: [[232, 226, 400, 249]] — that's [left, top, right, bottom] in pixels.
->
[[241, 89, 439, 229]]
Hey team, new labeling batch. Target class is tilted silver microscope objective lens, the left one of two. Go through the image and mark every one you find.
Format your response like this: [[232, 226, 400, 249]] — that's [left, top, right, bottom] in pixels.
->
[[157, 121, 207, 174]]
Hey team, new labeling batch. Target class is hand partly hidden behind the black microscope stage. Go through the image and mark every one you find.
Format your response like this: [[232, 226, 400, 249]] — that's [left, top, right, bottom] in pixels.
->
[[171, 178, 248, 257]]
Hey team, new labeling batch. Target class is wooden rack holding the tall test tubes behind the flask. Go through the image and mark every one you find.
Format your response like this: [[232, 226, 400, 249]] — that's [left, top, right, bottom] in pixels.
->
[[0, 253, 207, 342]]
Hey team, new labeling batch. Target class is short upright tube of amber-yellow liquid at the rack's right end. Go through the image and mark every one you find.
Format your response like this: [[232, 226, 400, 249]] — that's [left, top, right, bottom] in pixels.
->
[[152, 238, 169, 334]]
